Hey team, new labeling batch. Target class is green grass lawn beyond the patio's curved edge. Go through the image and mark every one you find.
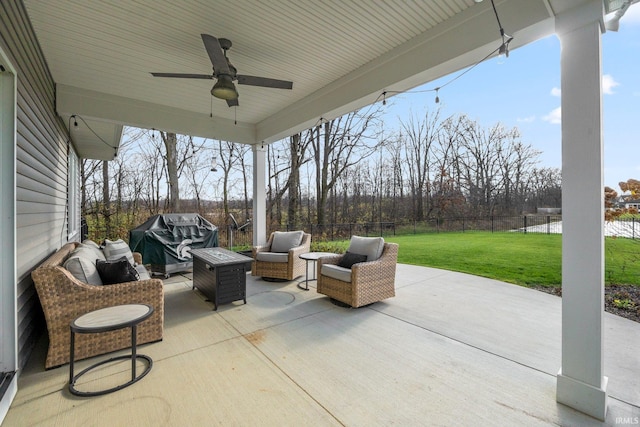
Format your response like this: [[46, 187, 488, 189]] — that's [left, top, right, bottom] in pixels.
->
[[385, 232, 640, 286]]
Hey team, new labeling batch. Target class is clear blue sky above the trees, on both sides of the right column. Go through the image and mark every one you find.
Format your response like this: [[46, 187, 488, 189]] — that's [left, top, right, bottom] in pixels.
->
[[386, 3, 640, 192]]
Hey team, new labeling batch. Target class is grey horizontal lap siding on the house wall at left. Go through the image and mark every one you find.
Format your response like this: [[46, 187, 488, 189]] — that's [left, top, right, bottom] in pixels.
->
[[0, 0, 73, 367]]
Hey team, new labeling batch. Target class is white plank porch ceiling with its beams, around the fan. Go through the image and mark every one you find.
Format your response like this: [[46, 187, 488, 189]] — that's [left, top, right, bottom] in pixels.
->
[[25, 0, 604, 159]]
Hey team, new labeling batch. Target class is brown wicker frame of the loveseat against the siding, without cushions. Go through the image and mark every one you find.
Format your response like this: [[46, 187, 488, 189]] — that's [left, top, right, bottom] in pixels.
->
[[31, 242, 164, 369]]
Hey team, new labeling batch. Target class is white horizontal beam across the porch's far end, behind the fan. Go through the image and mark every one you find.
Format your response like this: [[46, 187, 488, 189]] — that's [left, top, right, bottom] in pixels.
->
[[56, 84, 256, 144]]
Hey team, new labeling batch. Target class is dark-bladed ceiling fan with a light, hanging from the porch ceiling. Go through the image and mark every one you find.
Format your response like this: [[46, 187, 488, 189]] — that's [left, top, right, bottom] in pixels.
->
[[151, 34, 293, 107]]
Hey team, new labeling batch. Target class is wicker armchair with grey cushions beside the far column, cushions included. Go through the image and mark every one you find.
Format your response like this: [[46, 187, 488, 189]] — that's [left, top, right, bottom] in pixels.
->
[[251, 231, 311, 280]]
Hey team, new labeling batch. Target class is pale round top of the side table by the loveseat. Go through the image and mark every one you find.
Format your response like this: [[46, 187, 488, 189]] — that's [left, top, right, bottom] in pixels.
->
[[71, 304, 153, 330]]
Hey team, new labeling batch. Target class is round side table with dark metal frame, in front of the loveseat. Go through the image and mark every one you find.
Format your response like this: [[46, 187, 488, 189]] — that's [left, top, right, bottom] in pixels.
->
[[69, 304, 153, 396]]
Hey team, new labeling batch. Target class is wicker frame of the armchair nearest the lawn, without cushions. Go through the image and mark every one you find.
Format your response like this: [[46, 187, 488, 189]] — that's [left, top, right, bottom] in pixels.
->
[[317, 243, 398, 308]]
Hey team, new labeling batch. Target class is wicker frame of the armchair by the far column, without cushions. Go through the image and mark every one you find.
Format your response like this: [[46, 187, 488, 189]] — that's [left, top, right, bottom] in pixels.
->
[[251, 233, 311, 280]]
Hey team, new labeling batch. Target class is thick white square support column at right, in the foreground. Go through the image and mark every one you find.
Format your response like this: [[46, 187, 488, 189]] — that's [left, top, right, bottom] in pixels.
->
[[556, 0, 607, 420]]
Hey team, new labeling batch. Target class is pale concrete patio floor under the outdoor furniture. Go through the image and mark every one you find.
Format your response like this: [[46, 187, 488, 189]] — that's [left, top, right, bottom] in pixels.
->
[[3, 264, 640, 427]]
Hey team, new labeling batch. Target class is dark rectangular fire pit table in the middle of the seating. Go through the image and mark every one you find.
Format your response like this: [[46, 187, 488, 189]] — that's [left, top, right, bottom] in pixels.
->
[[191, 248, 253, 310]]
